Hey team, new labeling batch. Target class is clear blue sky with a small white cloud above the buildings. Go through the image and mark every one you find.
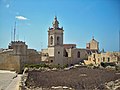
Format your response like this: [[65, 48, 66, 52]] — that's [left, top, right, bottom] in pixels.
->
[[0, 0, 120, 51]]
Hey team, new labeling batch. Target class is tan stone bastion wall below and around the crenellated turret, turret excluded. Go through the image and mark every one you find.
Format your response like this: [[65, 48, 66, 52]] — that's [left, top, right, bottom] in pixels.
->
[[0, 49, 41, 73]]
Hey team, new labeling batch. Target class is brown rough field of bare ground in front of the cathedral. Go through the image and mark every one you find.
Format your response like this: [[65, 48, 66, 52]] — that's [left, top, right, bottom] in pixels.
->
[[25, 67, 120, 90]]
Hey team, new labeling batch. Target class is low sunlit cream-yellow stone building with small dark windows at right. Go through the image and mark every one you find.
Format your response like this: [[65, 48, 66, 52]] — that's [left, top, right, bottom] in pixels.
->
[[85, 52, 120, 65]]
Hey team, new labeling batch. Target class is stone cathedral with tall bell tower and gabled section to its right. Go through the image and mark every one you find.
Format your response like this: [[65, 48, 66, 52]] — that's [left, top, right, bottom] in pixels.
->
[[41, 16, 99, 65]]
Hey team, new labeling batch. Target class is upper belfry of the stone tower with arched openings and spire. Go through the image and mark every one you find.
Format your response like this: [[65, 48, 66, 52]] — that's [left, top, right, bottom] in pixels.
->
[[48, 16, 63, 47]]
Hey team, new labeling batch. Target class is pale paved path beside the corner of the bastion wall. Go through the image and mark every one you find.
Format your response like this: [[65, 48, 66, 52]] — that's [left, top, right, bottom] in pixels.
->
[[0, 70, 22, 90]]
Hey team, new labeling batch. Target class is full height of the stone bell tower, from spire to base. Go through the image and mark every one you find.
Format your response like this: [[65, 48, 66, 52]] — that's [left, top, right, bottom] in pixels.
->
[[48, 16, 64, 64]]
